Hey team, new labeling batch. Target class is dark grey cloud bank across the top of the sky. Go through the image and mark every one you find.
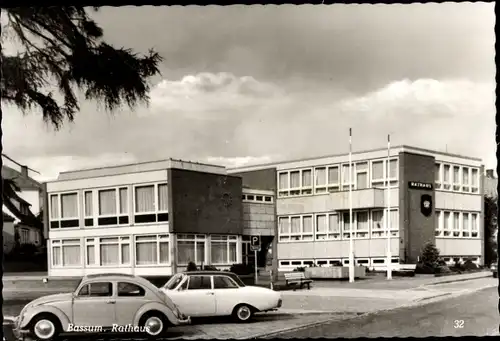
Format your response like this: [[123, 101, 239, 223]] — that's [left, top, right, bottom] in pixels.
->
[[96, 3, 495, 92]]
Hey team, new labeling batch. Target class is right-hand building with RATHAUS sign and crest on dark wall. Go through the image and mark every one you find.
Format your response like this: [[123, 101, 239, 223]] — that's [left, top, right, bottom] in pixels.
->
[[229, 146, 484, 270]]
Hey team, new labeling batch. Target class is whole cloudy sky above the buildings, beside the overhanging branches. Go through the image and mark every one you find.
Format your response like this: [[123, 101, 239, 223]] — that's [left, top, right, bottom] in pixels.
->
[[2, 3, 496, 179]]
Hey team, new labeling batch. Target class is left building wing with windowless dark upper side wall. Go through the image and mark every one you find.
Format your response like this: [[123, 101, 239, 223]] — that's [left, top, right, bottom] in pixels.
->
[[46, 159, 275, 276]]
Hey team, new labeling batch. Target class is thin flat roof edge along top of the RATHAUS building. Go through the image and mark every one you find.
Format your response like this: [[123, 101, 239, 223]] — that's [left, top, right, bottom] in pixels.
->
[[227, 145, 482, 172]]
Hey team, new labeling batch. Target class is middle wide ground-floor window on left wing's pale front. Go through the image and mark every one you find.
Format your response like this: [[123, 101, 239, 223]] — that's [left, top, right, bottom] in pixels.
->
[[99, 237, 130, 266]]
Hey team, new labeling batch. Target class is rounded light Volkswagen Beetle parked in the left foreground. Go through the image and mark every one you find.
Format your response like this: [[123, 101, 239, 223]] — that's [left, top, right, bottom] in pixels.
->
[[14, 274, 190, 340]]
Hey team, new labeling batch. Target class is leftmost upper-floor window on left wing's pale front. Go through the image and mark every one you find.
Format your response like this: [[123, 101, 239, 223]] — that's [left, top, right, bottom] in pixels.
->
[[49, 193, 80, 229]]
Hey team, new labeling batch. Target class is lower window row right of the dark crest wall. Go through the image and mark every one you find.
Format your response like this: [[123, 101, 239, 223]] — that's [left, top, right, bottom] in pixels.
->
[[435, 210, 480, 238]]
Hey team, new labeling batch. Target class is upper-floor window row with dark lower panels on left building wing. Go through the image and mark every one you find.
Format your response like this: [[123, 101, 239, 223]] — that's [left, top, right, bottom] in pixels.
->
[[49, 183, 168, 229]]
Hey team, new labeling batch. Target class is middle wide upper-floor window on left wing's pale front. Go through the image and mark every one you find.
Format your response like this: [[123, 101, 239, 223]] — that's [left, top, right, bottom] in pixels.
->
[[97, 187, 129, 226]]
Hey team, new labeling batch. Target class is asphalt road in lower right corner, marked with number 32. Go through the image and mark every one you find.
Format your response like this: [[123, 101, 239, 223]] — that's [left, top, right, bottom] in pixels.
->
[[272, 288, 499, 338]]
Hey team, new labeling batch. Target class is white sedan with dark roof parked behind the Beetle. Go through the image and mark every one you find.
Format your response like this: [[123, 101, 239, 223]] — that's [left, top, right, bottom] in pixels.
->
[[161, 271, 282, 322]]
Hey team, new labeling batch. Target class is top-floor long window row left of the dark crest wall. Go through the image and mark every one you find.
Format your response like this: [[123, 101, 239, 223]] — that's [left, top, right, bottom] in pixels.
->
[[278, 159, 398, 197]]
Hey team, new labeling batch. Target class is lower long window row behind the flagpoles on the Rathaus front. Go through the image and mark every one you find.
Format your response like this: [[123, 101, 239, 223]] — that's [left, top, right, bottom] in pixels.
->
[[278, 209, 399, 242]]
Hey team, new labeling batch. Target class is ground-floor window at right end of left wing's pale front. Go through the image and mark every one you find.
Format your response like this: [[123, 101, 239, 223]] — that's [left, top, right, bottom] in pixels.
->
[[135, 234, 170, 265]]
